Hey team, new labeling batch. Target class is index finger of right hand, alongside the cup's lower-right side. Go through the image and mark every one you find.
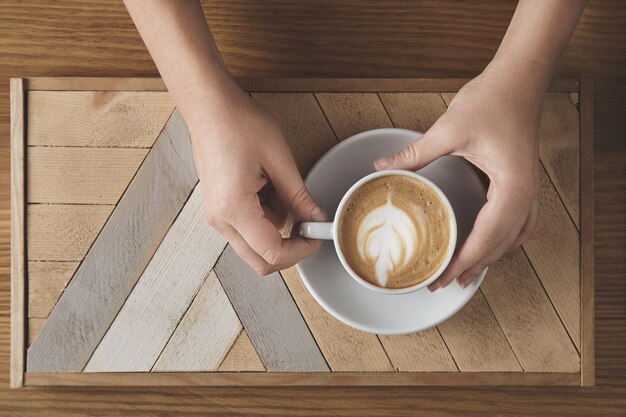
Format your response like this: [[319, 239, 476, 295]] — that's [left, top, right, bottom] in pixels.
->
[[428, 191, 524, 291]]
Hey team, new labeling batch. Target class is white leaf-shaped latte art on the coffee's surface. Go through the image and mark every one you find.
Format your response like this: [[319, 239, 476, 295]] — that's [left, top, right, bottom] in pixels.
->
[[357, 196, 418, 287]]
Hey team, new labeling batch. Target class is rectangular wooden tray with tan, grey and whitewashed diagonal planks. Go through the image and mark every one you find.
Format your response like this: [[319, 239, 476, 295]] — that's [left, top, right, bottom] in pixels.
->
[[11, 78, 594, 387]]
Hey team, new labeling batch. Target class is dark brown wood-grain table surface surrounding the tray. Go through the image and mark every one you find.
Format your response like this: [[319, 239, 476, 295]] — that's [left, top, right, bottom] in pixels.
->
[[0, 0, 626, 416]]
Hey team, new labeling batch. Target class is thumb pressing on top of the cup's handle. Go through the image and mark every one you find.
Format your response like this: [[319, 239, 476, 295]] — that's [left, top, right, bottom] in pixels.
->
[[270, 162, 328, 222]]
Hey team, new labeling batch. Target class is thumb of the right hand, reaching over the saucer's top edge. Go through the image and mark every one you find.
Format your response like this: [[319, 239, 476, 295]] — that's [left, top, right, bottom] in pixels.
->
[[374, 128, 452, 171]]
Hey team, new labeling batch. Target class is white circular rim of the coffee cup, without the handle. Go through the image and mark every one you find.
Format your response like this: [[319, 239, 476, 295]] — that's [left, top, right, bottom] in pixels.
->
[[333, 169, 457, 295]]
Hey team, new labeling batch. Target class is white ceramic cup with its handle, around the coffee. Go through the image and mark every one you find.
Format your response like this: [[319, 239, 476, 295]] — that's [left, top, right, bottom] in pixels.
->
[[299, 169, 457, 294]]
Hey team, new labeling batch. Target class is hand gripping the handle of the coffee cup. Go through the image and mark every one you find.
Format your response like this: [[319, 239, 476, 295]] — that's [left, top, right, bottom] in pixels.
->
[[190, 85, 327, 275]]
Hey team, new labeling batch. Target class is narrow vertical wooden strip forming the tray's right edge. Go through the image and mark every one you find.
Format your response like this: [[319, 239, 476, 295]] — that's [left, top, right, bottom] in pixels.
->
[[580, 78, 595, 386]]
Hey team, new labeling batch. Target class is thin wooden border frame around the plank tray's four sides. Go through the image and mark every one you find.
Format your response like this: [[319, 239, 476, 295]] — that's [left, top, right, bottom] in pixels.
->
[[10, 77, 595, 388]]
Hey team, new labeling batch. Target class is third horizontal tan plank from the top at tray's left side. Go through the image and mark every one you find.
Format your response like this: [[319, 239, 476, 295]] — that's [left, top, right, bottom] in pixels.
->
[[26, 204, 115, 261]]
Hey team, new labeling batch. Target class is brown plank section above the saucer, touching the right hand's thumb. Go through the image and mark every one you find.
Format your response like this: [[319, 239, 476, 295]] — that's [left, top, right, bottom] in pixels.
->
[[379, 93, 446, 133]]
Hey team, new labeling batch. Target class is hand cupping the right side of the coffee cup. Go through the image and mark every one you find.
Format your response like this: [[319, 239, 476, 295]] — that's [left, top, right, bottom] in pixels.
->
[[376, 68, 543, 291]]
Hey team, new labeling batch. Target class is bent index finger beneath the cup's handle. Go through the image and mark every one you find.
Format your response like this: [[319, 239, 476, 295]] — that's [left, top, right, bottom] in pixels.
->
[[229, 194, 321, 266]]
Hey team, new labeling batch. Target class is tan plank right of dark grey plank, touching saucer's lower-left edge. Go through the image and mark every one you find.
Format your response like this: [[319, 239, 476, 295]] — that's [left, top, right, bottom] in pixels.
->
[[281, 267, 395, 372]]
